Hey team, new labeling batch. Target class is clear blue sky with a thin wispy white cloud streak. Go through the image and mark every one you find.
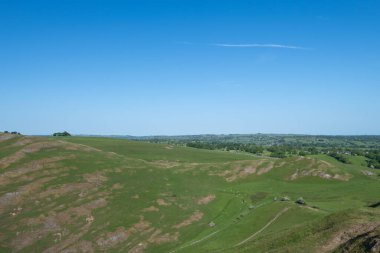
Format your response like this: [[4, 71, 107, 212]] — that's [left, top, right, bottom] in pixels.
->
[[0, 0, 380, 135]]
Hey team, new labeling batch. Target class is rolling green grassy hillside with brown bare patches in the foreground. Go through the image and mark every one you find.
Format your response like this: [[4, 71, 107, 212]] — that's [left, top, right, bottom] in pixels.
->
[[0, 134, 380, 253]]
